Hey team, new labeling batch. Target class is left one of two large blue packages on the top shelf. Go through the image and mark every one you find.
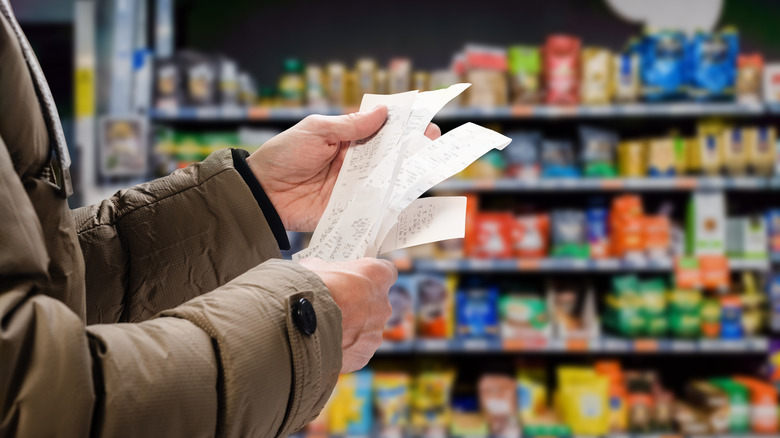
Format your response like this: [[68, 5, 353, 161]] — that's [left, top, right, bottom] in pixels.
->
[[636, 31, 686, 101]]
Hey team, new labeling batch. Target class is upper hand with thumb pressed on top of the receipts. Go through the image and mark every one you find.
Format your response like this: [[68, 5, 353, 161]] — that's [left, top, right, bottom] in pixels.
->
[[246, 105, 441, 231]]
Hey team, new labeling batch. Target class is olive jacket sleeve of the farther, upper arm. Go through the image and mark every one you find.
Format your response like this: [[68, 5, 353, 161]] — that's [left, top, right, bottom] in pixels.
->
[[74, 149, 286, 323]]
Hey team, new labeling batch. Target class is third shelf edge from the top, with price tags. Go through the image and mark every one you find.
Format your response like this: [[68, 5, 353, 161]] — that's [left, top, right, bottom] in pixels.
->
[[413, 258, 770, 272]]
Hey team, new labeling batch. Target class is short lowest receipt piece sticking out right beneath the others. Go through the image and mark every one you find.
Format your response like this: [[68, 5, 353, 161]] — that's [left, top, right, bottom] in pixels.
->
[[379, 196, 466, 254]]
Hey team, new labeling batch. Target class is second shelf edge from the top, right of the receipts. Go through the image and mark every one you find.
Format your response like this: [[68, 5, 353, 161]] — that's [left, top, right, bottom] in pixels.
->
[[431, 177, 780, 193]]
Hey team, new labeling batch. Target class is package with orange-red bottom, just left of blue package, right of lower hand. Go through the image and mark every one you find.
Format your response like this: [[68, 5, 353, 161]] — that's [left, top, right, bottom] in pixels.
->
[[417, 275, 456, 338]]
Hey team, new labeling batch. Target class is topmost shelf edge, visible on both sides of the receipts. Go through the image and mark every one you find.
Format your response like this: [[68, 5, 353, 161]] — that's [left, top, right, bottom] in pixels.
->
[[149, 102, 766, 122]]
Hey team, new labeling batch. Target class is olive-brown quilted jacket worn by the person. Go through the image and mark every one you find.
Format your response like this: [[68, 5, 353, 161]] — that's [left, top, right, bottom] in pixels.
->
[[0, 0, 341, 437]]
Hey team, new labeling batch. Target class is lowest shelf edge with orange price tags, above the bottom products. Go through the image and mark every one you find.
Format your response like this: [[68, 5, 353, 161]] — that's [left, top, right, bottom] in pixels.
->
[[377, 337, 769, 354]]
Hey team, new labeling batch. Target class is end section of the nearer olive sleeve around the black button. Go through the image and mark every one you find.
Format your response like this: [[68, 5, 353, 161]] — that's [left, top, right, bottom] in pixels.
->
[[161, 260, 341, 436]]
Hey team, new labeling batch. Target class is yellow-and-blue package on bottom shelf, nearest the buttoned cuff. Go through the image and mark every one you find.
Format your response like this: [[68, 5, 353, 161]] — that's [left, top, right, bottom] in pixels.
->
[[328, 370, 374, 435]]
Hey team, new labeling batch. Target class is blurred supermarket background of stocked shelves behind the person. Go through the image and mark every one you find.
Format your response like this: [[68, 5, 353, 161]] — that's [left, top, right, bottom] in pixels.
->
[[16, 0, 780, 437]]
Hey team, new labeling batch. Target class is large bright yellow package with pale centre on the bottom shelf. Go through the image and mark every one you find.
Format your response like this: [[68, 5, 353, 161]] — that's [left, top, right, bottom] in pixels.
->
[[556, 367, 609, 436]]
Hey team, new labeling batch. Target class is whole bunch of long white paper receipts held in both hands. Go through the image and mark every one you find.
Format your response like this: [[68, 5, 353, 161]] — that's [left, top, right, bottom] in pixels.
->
[[293, 84, 511, 261]]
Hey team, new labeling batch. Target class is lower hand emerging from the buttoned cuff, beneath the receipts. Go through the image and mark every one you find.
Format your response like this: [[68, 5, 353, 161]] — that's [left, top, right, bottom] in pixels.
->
[[299, 258, 398, 373]]
